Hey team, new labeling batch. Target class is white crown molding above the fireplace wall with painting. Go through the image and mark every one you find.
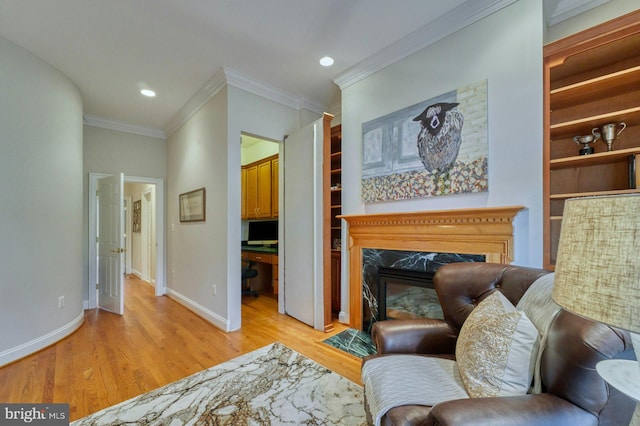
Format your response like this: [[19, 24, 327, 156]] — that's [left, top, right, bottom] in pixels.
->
[[333, 0, 517, 90]]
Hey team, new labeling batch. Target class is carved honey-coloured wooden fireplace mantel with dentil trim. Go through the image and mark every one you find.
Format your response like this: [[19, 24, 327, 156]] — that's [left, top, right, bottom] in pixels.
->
[[339, 206, 524, 330]]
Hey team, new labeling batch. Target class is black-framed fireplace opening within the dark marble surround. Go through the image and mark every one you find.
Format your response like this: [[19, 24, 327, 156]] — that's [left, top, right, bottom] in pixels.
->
[[377, 267, 444, 321]]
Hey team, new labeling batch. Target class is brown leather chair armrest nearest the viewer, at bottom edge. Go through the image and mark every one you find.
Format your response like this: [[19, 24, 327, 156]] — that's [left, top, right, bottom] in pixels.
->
[[426, 393, 598, 426]]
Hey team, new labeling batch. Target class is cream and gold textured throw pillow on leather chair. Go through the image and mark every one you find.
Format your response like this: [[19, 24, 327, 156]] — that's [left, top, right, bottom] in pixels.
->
[[456, 291, 538, 398]]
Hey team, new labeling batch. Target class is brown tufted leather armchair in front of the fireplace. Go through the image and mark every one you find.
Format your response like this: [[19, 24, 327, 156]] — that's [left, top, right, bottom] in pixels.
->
[[363, 263, 635, 426]]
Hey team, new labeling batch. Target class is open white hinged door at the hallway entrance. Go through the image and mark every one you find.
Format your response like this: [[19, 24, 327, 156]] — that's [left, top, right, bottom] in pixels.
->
[[97, 173, 125, 315]]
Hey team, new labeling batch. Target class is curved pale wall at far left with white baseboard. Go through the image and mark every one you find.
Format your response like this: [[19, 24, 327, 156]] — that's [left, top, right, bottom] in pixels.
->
[[0, 38, 84, 365]]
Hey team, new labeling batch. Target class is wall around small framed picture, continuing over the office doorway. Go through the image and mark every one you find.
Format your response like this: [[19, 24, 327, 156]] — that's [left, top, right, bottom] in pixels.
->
[[167, 81, 299, 330]]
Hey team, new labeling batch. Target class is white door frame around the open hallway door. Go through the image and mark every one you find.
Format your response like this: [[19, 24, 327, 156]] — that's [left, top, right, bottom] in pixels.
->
[[87, 173, 167, 309]]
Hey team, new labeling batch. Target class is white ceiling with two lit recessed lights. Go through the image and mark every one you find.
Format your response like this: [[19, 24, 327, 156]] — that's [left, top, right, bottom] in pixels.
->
[[0, 0, 588, 134]]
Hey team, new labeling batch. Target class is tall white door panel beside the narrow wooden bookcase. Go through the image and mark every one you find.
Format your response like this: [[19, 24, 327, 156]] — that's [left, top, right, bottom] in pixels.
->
[[281, 119, 324, 330]]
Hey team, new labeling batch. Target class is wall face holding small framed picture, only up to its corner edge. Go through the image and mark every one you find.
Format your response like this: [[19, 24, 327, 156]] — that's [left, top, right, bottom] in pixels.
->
[[167, 89, 230, 328]]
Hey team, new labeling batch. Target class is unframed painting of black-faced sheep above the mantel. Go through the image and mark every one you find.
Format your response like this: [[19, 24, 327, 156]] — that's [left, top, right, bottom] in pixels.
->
[[362, 80, 489, 203]]
